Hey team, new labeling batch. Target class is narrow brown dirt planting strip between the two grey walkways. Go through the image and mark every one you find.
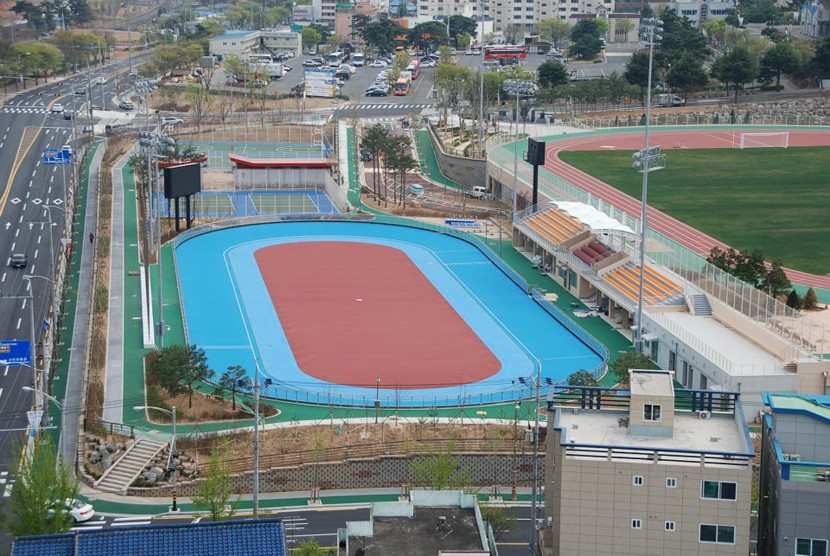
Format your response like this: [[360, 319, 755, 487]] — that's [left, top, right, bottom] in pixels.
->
[[85, 137, 132, 423]]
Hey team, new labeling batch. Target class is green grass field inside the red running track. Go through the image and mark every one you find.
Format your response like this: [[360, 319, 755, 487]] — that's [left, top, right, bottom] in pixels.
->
[[560, 147, 830, 274]]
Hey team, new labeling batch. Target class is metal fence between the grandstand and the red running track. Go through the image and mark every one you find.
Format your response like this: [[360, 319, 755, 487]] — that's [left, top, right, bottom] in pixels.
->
[[488, 128, 818, 355]]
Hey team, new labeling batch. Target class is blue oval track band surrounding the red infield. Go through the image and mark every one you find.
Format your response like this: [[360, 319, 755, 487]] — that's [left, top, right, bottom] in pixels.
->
[[176, 221, 602, 406]]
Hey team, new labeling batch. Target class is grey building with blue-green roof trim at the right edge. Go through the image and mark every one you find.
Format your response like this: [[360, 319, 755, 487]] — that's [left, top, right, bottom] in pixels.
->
[[758, 394, 830, 556]]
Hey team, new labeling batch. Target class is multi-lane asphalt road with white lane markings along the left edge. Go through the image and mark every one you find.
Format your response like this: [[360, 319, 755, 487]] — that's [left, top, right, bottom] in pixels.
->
[[0, 57, 140, 550]]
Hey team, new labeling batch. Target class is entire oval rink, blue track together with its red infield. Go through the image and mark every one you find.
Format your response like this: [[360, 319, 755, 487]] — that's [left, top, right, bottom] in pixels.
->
[[176, 220, 603, 407]]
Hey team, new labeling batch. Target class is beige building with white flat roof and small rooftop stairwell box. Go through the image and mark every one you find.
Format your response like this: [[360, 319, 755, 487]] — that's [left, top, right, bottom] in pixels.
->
[[541, 370, 754, 556]]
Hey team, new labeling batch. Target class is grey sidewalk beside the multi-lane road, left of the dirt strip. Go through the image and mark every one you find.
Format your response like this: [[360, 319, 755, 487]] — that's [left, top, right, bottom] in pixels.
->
[[60, 144, 105, 462]]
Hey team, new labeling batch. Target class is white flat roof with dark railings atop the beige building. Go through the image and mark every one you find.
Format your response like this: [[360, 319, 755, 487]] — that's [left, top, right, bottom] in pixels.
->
[[548, 384, 754, 458]]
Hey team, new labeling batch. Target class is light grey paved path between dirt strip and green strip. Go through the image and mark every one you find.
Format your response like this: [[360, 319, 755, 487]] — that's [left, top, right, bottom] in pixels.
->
[[103, 155, 129, 423]]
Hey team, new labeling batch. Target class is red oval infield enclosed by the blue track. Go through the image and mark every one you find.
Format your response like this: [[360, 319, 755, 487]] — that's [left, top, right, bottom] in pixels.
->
[[255, 241, 501, 388]]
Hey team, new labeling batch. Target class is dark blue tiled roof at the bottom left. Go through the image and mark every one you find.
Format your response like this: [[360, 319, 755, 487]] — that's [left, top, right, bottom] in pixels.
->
[[12, 519, 287, 556]]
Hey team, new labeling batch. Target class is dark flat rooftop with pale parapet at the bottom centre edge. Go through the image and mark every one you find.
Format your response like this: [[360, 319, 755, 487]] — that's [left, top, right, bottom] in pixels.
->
[[349, 508, 481, 556]]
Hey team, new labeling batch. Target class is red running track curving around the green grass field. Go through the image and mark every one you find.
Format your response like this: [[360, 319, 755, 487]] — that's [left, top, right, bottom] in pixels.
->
[[545, 129, 830, 288]]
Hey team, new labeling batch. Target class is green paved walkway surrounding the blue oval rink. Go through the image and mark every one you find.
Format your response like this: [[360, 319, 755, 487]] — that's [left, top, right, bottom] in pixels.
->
[[110, 129, 631, 434]]
